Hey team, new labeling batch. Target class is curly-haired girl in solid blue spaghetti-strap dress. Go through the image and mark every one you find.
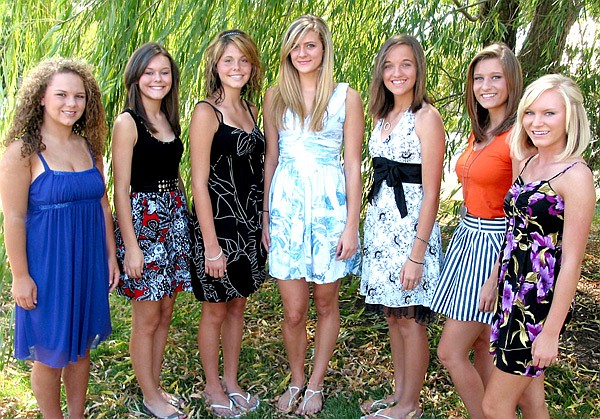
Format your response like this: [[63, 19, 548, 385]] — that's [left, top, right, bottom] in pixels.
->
[[0, 58, 119, 418]]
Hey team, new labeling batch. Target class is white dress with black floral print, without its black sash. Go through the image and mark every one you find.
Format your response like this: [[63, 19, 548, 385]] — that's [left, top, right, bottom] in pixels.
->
[[360, 110, 442, 308]]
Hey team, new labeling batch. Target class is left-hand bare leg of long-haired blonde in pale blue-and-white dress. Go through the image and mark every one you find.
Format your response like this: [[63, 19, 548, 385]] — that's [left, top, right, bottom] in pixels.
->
[[277, 279, 310, 410]]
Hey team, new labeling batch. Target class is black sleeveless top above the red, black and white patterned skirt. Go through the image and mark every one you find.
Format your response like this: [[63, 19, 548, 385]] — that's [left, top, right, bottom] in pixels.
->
[[124, 109, 183, 192]]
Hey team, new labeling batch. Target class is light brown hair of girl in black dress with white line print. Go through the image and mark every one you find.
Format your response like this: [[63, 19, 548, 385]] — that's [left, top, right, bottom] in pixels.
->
[[204, 29, 263, 103]]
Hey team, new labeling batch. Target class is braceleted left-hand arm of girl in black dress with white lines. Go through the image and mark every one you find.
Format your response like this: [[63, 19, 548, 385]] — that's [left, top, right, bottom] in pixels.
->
[[190, 103, 227, 278]]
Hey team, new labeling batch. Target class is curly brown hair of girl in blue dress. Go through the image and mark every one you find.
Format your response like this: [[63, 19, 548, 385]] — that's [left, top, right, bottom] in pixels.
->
[[4, 58, 108, 158]]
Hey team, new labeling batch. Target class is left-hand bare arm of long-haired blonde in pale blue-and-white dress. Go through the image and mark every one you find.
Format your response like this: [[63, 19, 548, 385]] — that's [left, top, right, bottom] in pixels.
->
[[262, 89, 279, 251]]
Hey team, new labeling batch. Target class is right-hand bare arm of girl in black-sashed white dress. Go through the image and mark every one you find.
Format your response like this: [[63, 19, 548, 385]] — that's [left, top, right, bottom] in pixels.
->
[[400, 104, 445, 290]]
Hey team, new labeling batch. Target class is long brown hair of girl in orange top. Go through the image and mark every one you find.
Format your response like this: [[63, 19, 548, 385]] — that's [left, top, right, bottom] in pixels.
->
[[465, 43, 523, 142]]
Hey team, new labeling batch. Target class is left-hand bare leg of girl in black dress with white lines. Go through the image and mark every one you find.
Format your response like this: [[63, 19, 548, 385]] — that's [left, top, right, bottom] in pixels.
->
[[198, 301, 234, 415]]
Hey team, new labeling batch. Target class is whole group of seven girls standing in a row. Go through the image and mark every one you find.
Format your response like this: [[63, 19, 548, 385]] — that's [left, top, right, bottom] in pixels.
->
[[0, 11, 595, 418]]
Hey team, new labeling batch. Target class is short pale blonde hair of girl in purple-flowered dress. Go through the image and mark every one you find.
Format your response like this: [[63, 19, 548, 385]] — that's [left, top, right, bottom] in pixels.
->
[[510, 74, 591, 160]]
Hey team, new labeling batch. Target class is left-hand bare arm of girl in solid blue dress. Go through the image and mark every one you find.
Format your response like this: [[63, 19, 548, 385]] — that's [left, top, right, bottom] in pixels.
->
[[0, 141, 37, 310]]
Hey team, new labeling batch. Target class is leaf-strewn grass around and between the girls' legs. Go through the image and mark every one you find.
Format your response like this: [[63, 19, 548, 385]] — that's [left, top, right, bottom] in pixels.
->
[[0, 215, 600, 419]]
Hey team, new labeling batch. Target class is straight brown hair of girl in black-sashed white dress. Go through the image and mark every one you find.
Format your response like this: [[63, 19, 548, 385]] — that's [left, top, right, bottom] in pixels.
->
[[369, 35, 430, 118]]
